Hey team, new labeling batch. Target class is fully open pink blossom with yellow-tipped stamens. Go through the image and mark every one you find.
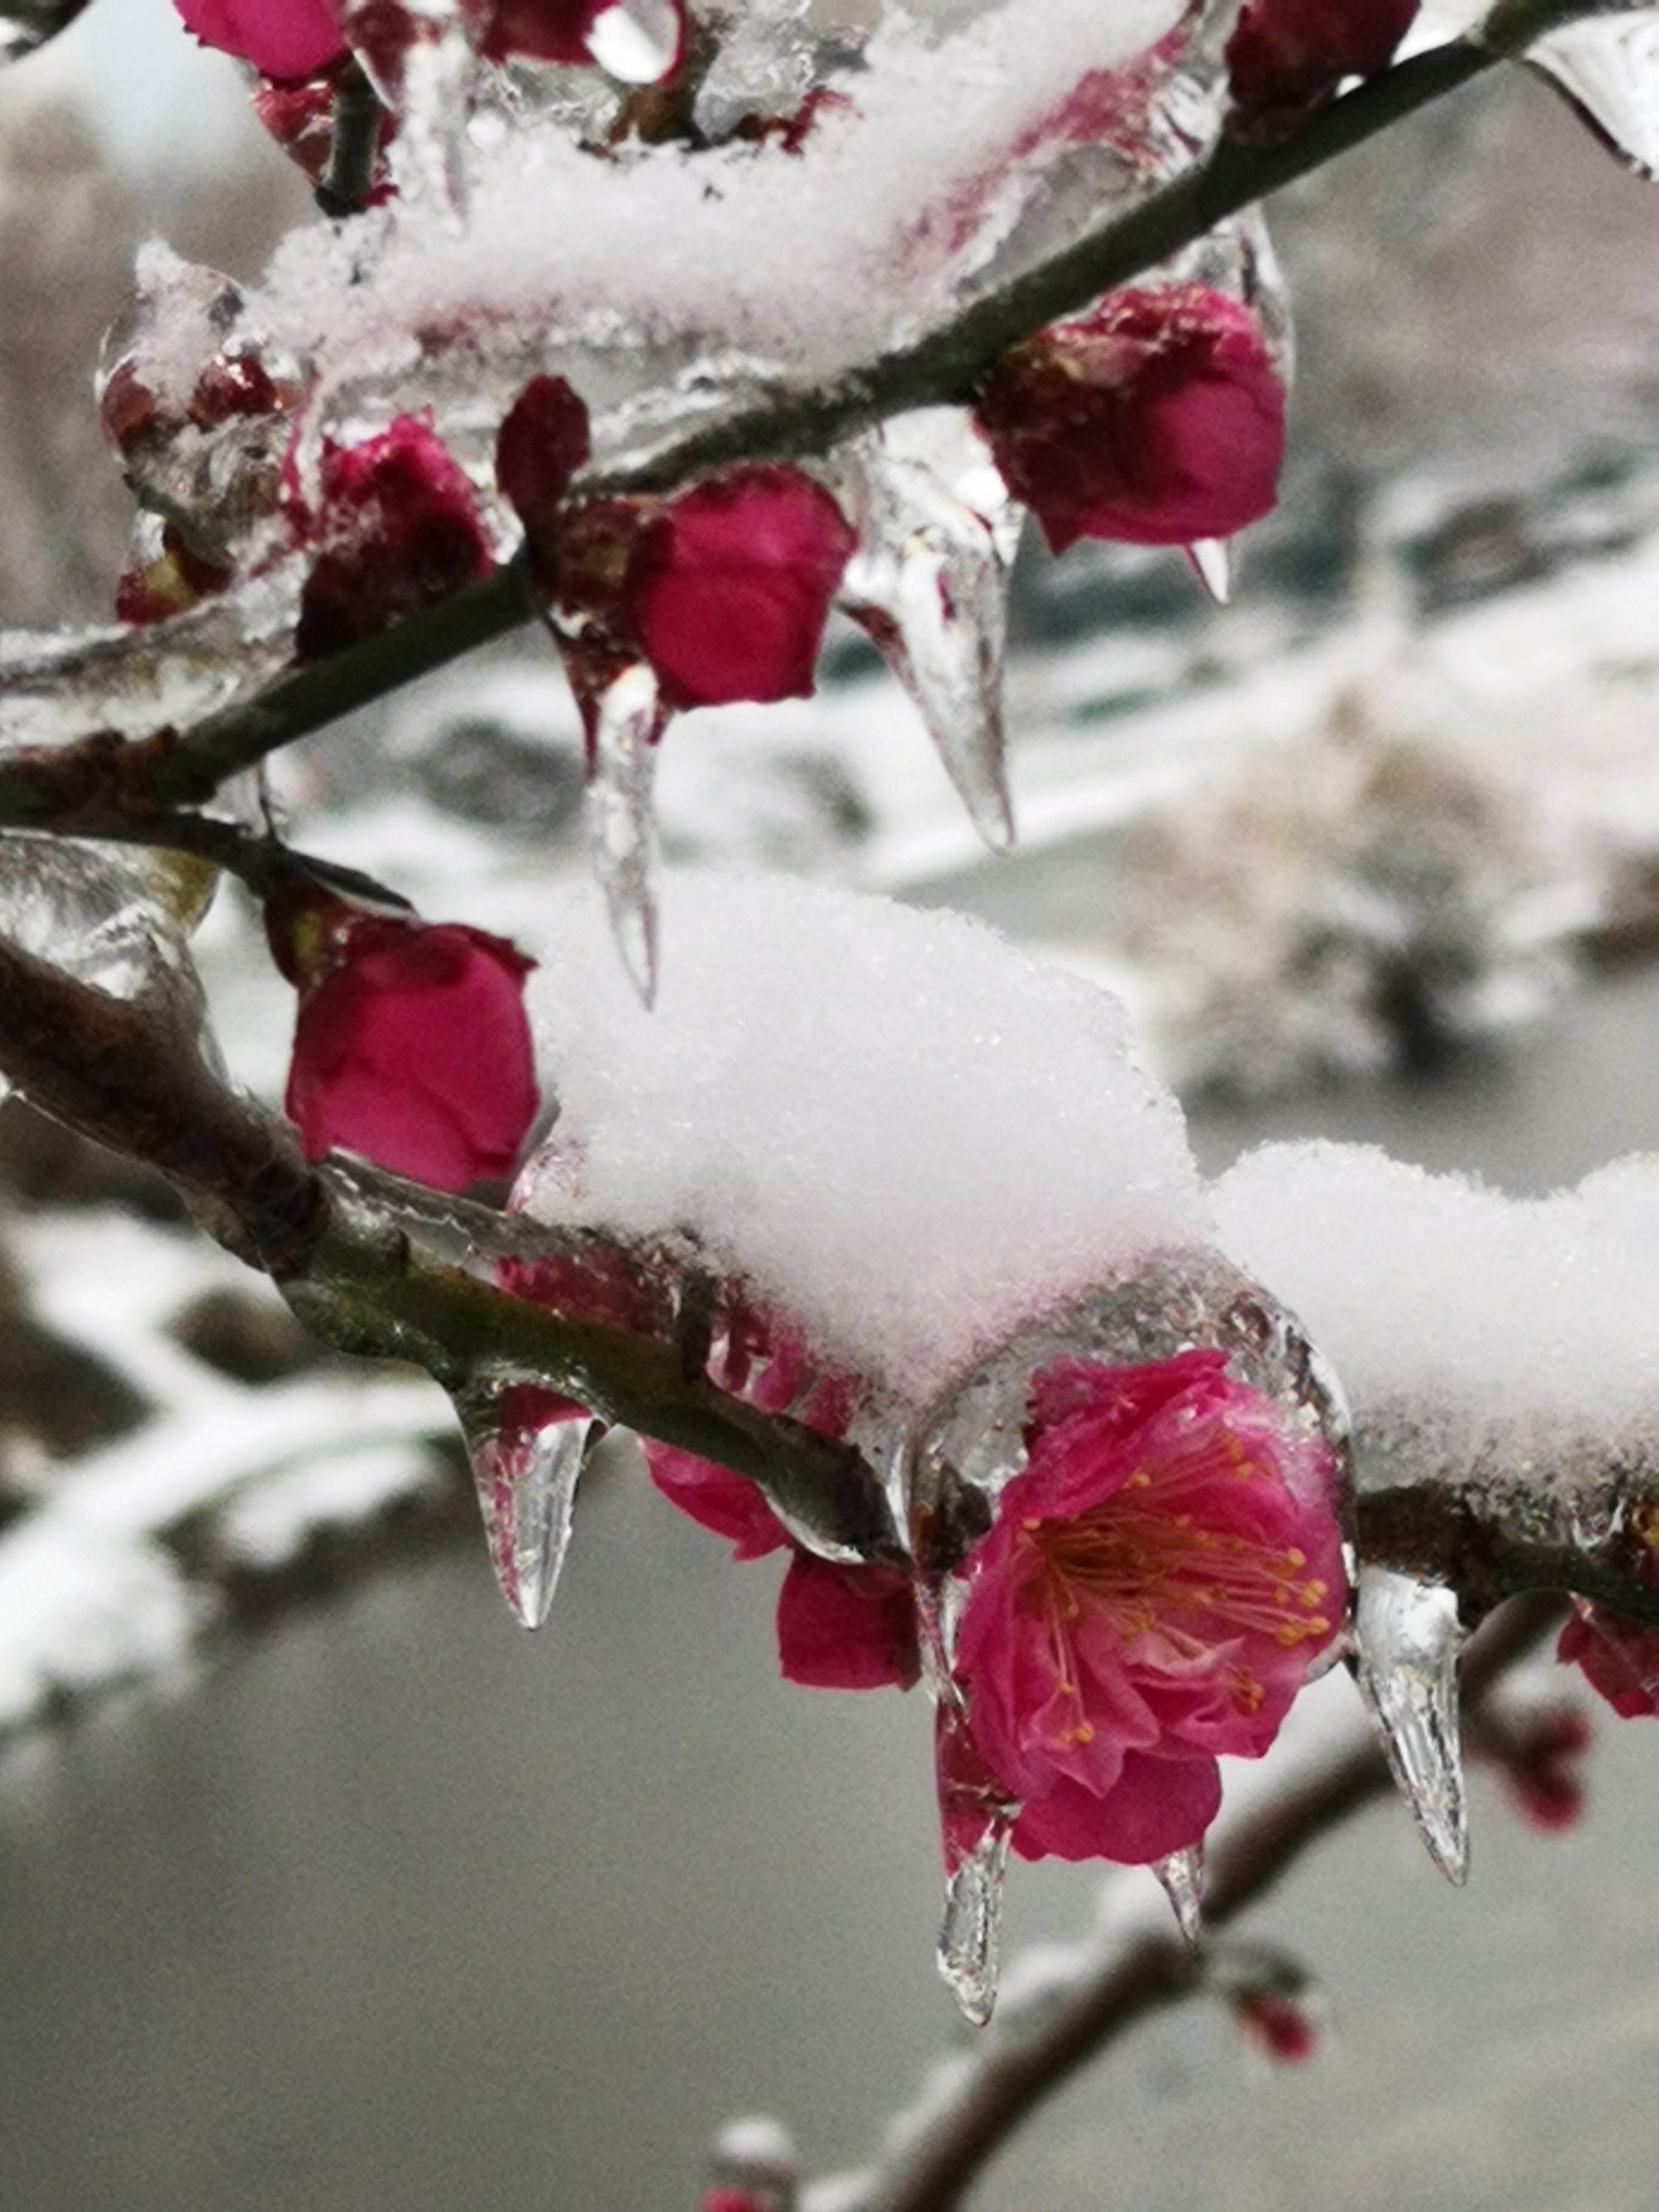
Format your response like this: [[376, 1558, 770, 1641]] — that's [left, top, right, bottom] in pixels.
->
[[955, 1351, 1345, 1862]]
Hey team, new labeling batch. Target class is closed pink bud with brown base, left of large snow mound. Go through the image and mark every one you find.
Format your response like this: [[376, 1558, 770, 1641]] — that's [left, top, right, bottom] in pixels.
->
[[265, 874, 537, 1190]]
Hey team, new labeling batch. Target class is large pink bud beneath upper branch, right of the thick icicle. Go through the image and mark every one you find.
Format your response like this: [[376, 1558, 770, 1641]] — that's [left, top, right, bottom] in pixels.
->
[[976, 283, 1285, 553]]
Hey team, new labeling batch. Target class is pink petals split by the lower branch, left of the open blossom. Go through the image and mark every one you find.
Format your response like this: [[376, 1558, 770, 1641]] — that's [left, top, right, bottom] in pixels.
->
[[646, 1301, 920, 1690]]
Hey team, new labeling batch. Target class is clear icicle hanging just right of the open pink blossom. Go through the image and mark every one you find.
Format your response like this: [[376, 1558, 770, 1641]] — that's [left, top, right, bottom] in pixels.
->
[[1354, 1566, 1469, 1883]]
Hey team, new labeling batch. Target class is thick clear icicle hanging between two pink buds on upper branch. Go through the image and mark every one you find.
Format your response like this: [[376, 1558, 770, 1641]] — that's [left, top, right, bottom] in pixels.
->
[[841, 407, 1022, 852]]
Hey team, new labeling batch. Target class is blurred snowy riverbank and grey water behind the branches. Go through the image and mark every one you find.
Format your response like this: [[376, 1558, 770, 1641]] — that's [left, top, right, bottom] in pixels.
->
[[0, 0, 1659, 2212]]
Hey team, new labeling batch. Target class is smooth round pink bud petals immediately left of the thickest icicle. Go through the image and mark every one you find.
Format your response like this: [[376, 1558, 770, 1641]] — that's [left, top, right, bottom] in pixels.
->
[[624, 467, 854, 708]]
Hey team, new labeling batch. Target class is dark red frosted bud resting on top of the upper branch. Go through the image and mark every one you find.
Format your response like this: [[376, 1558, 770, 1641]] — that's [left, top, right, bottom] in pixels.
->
[[294, 416, 493, 659]]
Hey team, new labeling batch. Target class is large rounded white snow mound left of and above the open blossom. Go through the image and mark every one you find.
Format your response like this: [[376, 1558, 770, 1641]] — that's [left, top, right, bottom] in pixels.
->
[[520, 876, 1206, 1394]]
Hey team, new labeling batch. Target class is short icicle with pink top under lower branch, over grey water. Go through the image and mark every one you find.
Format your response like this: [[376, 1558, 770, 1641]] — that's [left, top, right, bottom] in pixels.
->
[[460, 1382, 595, 1628]]
